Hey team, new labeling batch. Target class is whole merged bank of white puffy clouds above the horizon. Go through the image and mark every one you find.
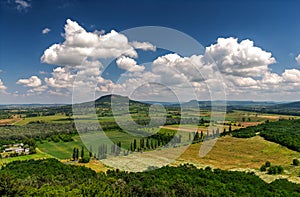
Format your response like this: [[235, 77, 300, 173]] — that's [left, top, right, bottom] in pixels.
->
[[33, 19, 300, 99]]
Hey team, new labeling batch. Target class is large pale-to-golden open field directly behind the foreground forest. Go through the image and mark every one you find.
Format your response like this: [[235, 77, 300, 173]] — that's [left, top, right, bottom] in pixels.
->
[[97, 136, 300, 183]]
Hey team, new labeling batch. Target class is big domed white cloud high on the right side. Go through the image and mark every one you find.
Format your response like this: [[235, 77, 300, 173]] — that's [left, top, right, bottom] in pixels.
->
[[205, 38, 276, 77]]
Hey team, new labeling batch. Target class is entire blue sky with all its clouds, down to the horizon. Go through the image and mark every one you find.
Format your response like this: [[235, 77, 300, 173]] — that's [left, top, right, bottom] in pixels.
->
[[0, 0, 300, 104]]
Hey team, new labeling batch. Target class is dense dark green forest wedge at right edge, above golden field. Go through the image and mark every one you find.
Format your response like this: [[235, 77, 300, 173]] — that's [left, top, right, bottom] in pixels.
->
[[222, 119, 300, 152]]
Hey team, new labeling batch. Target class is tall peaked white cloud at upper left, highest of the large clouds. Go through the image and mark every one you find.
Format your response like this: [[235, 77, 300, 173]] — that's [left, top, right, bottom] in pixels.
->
[[41, 19, 154, 66]]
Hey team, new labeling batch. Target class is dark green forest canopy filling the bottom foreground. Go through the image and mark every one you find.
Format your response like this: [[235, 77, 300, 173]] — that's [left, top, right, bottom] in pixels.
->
[[0, 159, 300, 197]]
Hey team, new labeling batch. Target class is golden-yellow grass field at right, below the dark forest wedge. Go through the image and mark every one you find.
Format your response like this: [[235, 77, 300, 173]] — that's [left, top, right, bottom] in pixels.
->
[[178, 136, 300, 177]]
